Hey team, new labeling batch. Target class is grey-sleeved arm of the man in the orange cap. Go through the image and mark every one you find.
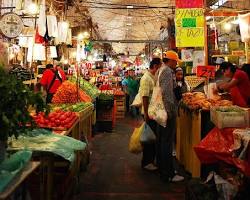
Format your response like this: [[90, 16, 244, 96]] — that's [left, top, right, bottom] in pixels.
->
[[159, 69, 175, 118]]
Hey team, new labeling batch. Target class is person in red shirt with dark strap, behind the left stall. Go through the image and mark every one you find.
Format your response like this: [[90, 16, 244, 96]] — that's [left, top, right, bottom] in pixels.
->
[[40, 64, 66, 103]]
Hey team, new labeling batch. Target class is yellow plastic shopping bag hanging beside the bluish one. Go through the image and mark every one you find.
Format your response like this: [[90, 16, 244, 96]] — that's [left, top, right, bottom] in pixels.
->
[[128, 124, 144, 154]]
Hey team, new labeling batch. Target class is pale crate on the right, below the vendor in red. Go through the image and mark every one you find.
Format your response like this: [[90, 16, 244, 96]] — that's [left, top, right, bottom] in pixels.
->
[[210, 106, 249, 129]]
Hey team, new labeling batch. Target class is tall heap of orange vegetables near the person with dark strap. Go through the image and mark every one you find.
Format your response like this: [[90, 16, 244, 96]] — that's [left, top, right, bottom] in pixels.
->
[[52, 81, 92, 104]]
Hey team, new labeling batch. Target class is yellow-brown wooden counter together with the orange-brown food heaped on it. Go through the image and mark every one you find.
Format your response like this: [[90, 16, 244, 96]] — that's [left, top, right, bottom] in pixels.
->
[[176, 92, 232, 177]]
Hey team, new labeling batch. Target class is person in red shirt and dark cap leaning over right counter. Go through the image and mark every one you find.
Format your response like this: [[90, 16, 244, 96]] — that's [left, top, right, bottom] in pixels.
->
[[218, 62, 250, 107]]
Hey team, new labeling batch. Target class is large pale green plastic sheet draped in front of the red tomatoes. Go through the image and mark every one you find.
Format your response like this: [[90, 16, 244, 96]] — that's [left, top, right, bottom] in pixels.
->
[[8, 129, 86, 162]]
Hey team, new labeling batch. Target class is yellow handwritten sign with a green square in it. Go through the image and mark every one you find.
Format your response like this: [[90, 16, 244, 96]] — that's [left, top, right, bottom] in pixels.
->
[[175, 8, 205, 47]]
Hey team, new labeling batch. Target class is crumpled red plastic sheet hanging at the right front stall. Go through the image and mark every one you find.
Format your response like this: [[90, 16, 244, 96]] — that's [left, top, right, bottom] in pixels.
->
[[194, 128, 250, 176]]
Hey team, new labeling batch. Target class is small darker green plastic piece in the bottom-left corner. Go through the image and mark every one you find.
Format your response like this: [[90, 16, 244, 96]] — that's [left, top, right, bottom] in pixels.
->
[[0, 151, 32, 192]]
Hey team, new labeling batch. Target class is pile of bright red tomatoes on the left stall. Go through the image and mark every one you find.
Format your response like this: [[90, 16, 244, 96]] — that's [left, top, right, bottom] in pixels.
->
[[33, 110, 78, 130]]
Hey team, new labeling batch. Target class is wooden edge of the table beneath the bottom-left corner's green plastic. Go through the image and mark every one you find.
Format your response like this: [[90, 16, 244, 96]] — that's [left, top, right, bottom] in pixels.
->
[[0, 161, 40, 200]]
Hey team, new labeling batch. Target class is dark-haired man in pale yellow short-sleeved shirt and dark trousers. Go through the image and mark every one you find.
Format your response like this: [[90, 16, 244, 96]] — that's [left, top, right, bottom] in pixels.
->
[[139, 58, 162, 170]]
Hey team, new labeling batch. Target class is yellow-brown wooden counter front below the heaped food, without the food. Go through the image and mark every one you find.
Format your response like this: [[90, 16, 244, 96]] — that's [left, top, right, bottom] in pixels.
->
[[176, 108, 214, 177]]
